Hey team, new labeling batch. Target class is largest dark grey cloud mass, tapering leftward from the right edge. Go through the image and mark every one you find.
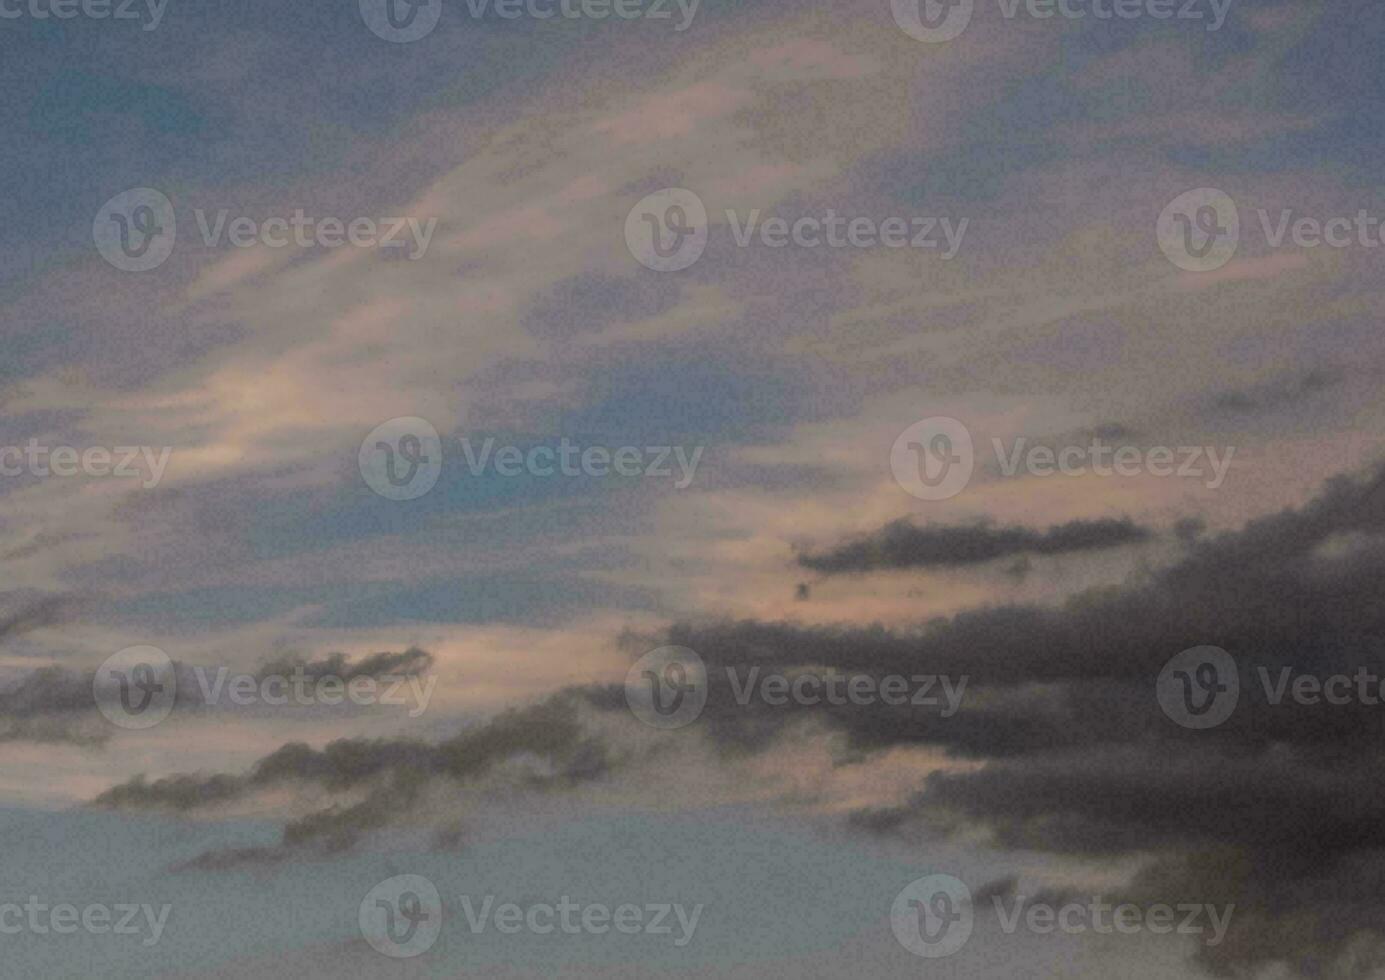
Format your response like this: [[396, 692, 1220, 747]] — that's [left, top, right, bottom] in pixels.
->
[[89, 468, 1385, 977]]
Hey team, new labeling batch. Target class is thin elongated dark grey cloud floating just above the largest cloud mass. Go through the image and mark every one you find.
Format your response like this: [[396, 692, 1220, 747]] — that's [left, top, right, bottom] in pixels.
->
[[798, 518, 1151, 574]]
